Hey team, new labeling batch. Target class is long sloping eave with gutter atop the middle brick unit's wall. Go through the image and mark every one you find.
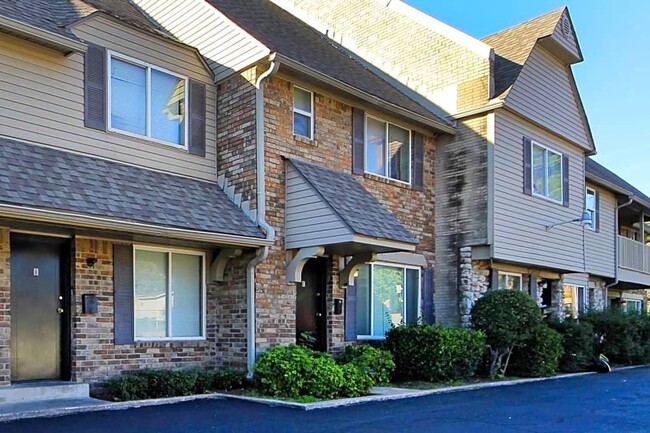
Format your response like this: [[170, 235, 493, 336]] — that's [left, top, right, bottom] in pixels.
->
[[271, 52, 456, 135]]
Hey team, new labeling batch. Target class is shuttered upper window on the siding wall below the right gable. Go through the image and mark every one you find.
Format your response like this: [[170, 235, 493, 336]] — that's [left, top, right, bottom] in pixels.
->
[[531, 142, 563, 203]]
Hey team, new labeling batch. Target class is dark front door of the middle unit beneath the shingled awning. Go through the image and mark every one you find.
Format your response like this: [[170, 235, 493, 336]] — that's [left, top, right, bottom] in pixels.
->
[[296, 257, 327, 352]]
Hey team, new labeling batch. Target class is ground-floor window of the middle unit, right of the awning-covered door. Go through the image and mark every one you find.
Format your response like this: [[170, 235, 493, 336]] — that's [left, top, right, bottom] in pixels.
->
[[356, 264, 420, 338]]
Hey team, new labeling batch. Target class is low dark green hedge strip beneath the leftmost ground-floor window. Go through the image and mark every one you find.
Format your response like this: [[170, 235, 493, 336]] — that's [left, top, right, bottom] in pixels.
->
[[107, 369, 248, 401]]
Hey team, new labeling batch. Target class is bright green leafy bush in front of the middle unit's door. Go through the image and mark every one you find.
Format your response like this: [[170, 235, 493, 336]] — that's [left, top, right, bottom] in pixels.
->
[[255, 345, 374, 399]]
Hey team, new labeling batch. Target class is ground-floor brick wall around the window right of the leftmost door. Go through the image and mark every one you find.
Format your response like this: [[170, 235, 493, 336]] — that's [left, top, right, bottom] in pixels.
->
[[71, 238, 250, 383]]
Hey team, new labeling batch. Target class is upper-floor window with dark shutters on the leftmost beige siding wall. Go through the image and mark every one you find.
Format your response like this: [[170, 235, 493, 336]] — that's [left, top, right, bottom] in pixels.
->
[[108, 53, 188, 149]]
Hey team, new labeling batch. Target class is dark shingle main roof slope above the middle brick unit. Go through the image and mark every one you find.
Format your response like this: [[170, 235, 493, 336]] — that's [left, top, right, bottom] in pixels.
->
[[208, 0, 451, 126]]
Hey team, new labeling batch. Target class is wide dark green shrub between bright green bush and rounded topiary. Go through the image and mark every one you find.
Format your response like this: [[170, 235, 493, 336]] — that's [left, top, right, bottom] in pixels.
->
[[386, 324, 485, 382]]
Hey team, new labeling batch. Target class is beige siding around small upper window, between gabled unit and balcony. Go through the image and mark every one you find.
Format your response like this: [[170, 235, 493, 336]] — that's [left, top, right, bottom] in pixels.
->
[[585, 183, 616, 277]]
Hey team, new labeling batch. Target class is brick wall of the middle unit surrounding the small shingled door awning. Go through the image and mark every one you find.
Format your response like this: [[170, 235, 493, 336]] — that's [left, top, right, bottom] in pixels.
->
[[248, 73, 435, 351]]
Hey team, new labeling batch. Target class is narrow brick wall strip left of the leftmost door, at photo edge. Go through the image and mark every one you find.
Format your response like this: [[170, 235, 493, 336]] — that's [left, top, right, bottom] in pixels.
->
[[0, 227, 11, 386]]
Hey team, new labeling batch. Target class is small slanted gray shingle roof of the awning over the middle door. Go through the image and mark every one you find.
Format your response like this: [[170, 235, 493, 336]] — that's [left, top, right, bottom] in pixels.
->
[[289, 159, 418, 244]]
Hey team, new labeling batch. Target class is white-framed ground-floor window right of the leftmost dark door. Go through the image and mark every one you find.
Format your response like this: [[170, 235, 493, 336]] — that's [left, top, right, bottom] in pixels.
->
[[133, 247, 205, 340]]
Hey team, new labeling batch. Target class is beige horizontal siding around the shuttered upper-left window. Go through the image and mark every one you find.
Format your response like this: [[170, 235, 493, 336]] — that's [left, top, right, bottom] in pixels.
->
[[0, 17, 216, 181]]
